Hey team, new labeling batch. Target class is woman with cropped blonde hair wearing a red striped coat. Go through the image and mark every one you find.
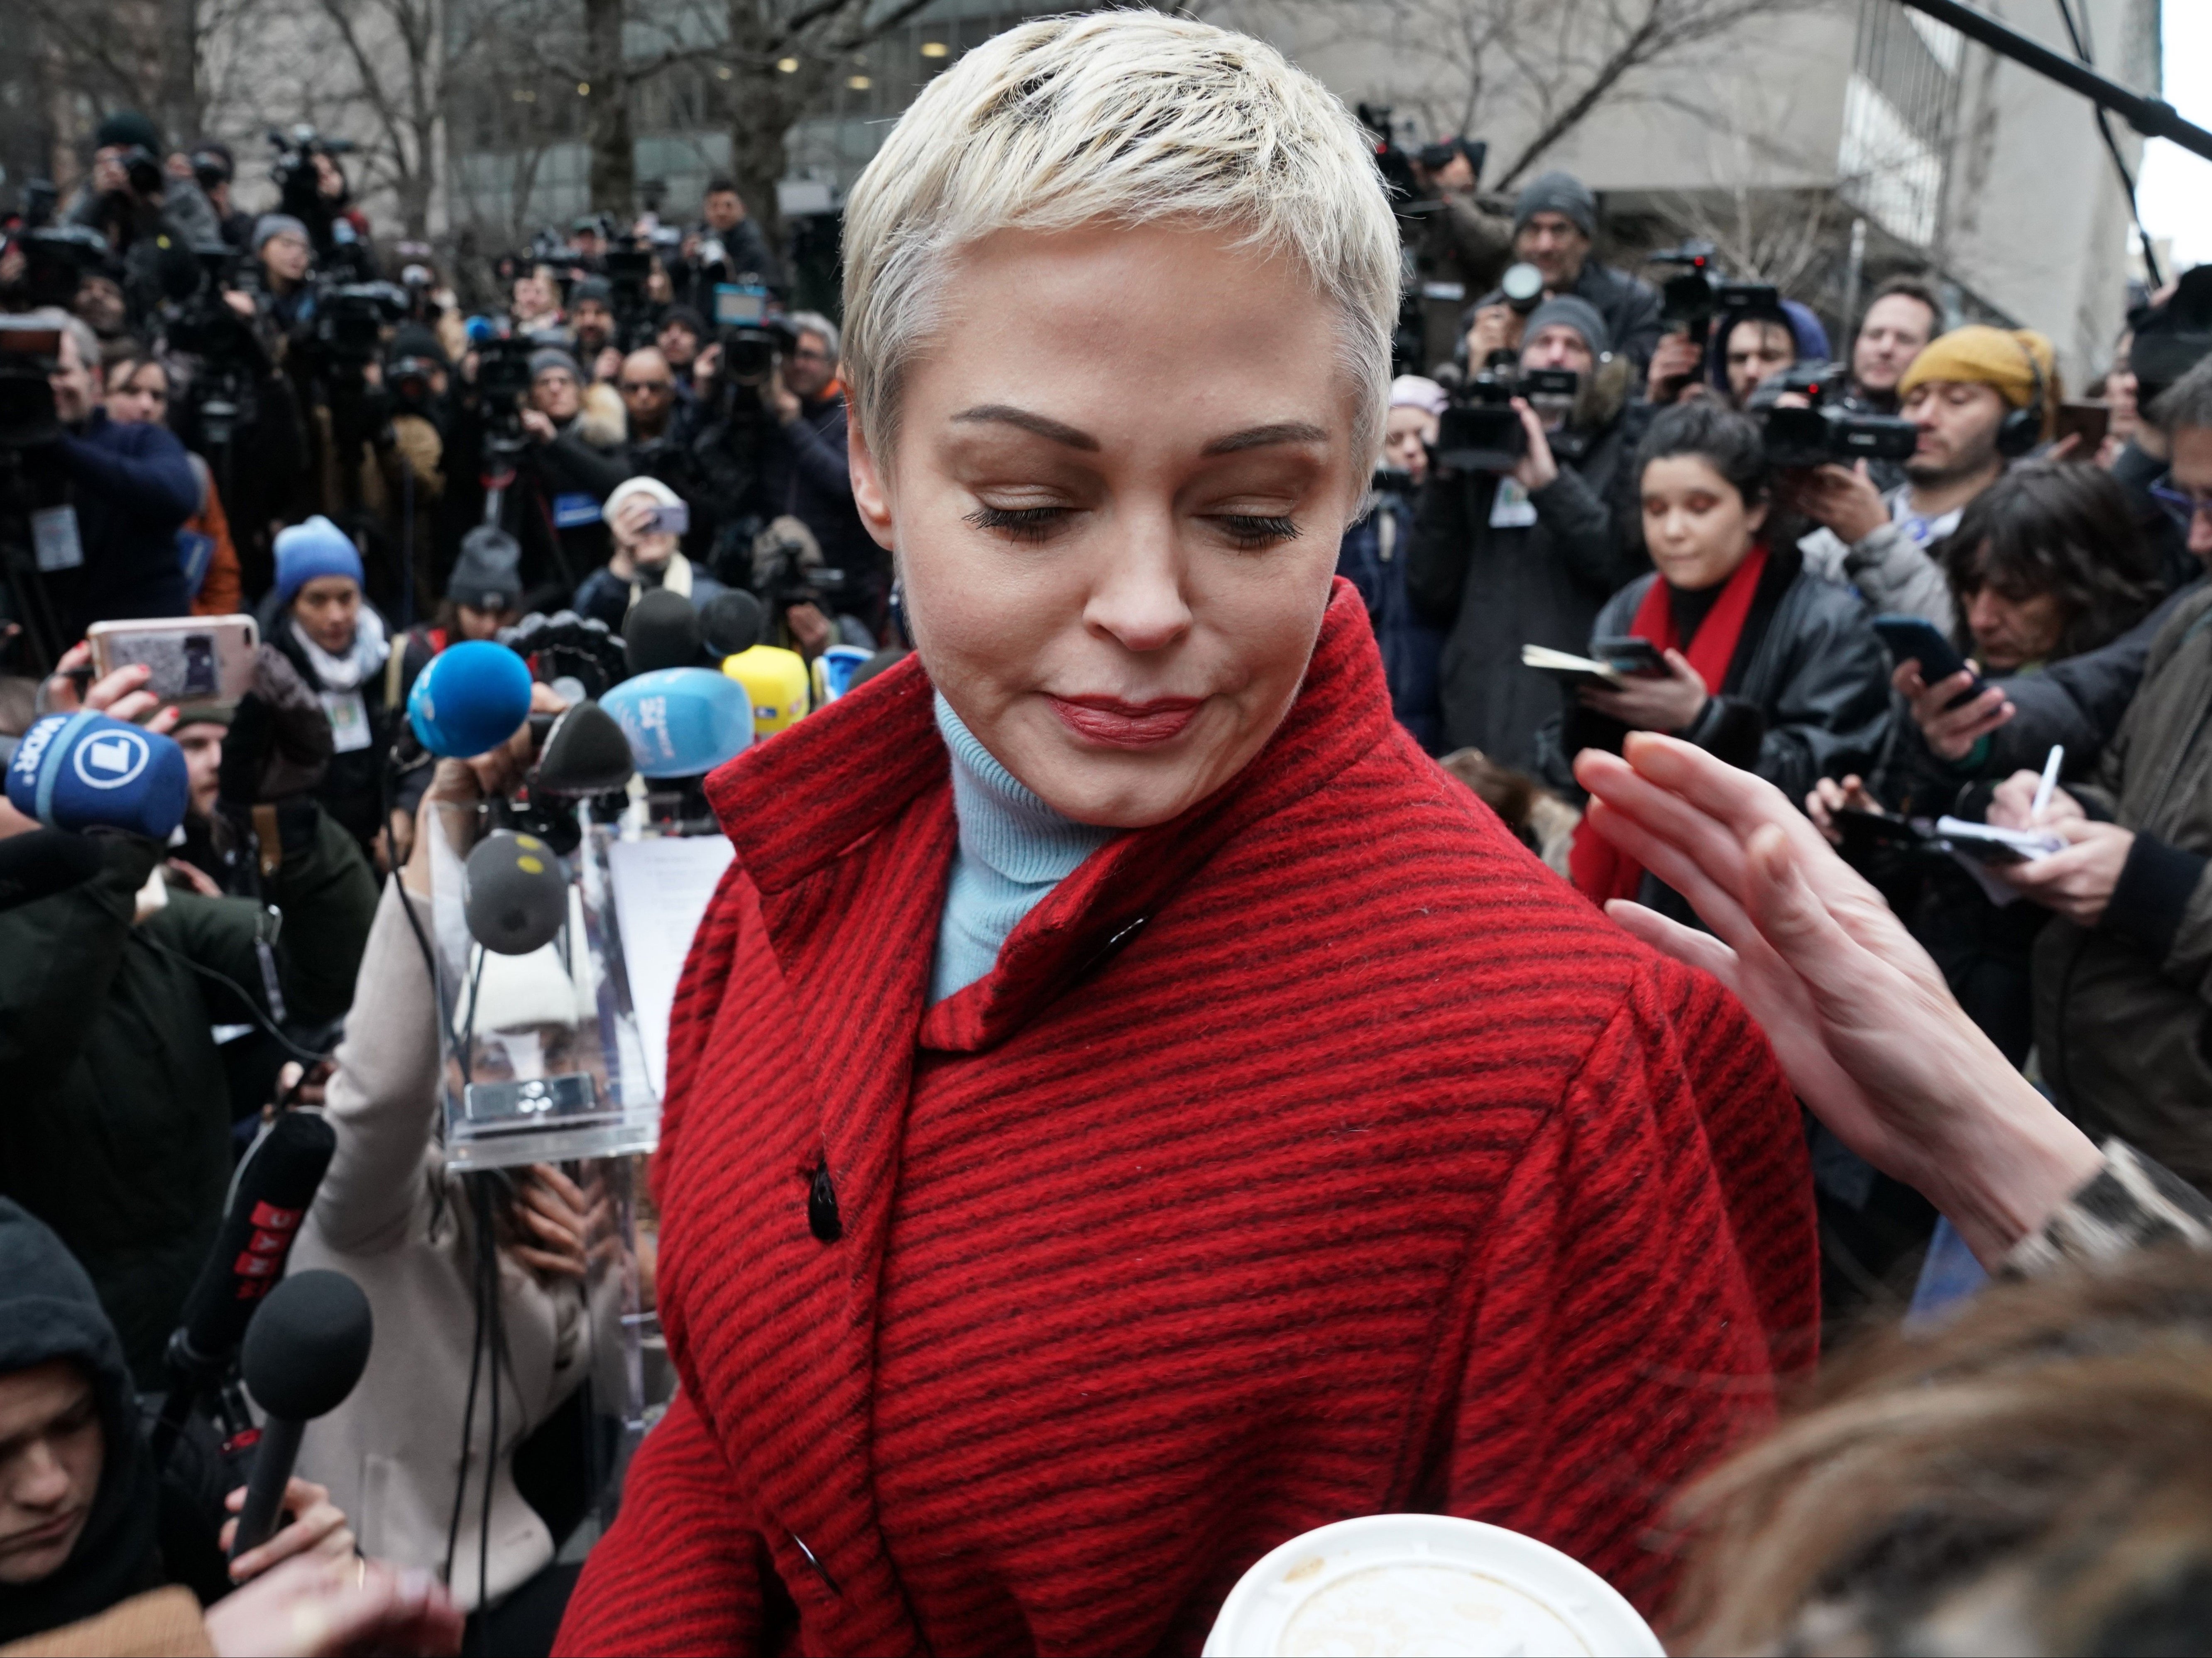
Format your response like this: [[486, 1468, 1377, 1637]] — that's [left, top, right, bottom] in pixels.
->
[[560, 11, 1816, 1656]]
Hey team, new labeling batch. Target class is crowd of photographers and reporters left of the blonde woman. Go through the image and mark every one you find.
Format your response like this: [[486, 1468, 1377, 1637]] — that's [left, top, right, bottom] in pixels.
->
[[0, 113, 900, 1653]]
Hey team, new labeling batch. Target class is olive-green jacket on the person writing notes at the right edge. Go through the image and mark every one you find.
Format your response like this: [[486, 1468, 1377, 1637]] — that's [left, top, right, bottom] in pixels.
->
[[2035, 592, 2212, 1189]]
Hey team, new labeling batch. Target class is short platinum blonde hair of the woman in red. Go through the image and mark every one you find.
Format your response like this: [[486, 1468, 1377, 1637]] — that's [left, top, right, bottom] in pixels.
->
[[843, 11, 1400, 477]]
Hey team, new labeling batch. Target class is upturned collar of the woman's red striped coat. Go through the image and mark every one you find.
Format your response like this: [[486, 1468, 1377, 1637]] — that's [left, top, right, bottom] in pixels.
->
[[708, 577, 1391, 1052]]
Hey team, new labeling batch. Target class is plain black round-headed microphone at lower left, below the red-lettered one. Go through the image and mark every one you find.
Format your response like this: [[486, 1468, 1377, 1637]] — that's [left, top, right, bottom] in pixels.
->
[[230, 1271, 376, 1561]]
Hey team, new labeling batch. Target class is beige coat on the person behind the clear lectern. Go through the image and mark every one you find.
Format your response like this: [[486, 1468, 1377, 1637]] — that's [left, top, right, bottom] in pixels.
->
[[290, 882, 593, 1612]]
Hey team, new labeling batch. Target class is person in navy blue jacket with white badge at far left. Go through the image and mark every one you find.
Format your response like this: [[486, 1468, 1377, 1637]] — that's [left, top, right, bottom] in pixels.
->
[[29, 312, 199, 648]]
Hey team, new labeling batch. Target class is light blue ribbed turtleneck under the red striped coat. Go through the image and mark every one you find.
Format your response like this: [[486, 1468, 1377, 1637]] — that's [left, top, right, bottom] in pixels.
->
[[929, 694, 1113, 1006]]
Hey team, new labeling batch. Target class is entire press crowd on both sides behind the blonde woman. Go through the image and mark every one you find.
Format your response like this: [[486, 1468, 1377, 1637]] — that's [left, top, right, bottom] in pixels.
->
[[0, 97, 2212, 1651]]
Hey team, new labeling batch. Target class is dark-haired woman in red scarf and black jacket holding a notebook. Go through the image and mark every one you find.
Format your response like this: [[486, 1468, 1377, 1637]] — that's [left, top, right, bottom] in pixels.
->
[[1551, 400, 1889, 917]]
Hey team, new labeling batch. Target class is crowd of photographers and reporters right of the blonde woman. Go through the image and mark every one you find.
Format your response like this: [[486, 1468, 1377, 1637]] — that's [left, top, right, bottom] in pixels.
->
[[1338, 142, 2212, 1324]]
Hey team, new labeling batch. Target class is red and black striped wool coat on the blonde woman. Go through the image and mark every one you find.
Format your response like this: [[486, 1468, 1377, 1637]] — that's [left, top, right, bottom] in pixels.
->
[[560, 582, 1816, 1658]]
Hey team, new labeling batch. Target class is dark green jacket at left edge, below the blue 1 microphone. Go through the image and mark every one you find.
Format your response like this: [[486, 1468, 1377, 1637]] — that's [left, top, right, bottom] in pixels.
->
[[0, 807, 376, 1386]]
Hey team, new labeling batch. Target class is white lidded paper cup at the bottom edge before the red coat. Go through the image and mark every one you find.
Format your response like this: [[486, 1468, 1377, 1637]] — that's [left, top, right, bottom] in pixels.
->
[[1206, 1514, 1666, 1658]]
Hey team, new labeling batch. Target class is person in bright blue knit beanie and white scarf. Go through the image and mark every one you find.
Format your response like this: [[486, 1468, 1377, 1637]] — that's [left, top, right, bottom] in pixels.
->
[[261, 513, 400, 869]]
